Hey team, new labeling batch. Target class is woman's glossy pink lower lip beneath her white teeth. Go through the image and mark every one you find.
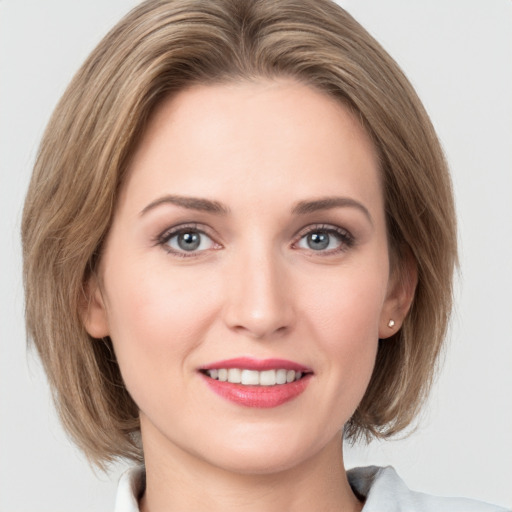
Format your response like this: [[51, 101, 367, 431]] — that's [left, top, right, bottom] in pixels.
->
[[202, 374, 311, 409]]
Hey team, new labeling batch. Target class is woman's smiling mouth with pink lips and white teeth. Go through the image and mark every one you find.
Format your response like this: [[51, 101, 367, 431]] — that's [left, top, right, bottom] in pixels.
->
[[199, 358, 313, 408]]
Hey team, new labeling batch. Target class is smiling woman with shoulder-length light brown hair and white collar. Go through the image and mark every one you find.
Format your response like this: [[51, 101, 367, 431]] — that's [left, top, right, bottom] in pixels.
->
[[19, 1, 508, 511]]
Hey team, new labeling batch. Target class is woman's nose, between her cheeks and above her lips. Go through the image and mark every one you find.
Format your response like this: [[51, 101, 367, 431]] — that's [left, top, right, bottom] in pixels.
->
[[224, 248, 295, 339]]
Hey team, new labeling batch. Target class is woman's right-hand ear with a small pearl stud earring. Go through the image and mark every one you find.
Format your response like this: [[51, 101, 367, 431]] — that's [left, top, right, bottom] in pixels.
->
[[379, 251, 418, 339]]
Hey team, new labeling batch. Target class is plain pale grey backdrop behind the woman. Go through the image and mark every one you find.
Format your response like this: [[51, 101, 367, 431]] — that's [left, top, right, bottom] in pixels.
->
[[0, 0, 512, 512]]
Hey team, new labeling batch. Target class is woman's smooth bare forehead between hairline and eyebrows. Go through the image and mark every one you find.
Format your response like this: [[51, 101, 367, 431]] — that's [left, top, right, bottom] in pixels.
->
[[121, 80, 381, 214]]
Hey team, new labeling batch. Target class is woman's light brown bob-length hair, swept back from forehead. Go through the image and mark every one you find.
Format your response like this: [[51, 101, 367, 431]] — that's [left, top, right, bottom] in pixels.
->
[[22, 0, 457, 467]]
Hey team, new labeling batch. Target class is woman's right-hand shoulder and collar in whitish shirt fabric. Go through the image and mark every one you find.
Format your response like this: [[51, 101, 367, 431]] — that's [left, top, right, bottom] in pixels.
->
[[348, 466, 510, 512]]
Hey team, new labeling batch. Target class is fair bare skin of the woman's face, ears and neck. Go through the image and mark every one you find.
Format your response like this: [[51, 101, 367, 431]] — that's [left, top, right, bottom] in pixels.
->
[[85, 80, 412, 512]]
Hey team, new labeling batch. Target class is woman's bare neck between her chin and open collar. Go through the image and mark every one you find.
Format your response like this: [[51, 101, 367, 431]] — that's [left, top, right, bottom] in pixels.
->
[[140, 435, 362, 512]]
